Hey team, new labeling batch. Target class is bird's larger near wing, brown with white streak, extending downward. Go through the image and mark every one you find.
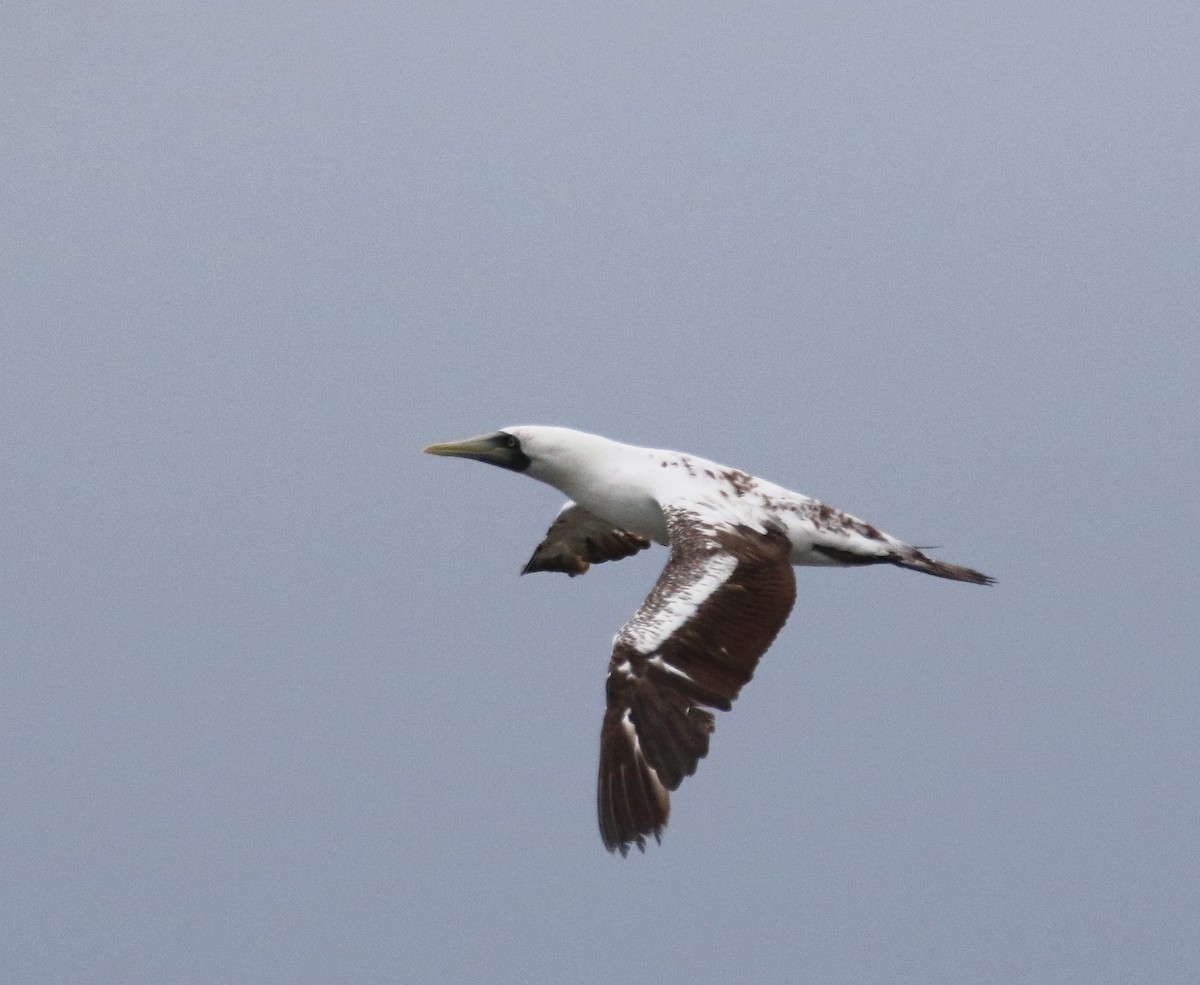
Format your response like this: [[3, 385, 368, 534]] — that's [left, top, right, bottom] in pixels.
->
[[596, 507, 796, 855]]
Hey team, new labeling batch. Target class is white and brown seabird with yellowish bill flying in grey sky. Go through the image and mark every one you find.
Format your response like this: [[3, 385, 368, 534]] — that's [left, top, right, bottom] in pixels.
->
[[425, 426, 992, 855]]
